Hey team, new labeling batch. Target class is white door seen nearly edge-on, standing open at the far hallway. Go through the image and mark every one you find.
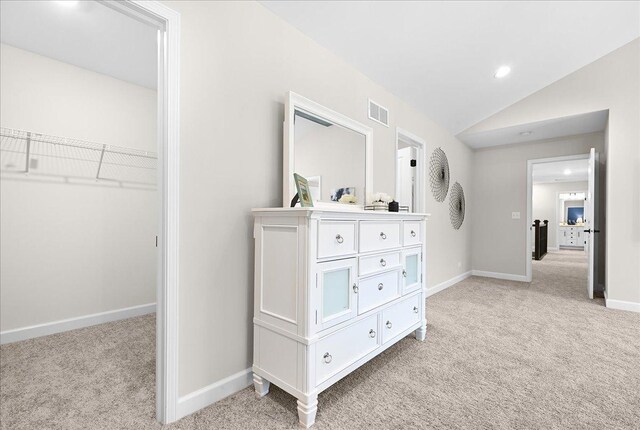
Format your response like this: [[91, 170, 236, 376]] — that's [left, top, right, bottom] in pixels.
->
[[584, 148, 599, 299]]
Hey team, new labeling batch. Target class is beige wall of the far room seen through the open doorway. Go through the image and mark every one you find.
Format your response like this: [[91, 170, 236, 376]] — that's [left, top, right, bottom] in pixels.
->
[[531, 182, 588, 248]]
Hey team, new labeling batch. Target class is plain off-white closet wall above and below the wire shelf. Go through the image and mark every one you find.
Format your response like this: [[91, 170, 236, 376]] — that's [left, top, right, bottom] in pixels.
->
[[0, 45, 158, 334]]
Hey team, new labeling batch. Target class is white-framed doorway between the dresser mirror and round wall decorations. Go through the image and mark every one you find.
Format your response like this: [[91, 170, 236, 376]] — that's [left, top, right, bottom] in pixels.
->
[[395, 128, 426, 212]]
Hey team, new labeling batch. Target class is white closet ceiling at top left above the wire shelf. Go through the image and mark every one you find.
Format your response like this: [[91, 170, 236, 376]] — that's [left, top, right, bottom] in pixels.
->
[[0, 1, 157, 89]]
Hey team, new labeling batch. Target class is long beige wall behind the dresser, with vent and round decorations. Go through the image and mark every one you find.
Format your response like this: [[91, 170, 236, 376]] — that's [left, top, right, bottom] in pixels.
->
[[166, 1, 473, 395]]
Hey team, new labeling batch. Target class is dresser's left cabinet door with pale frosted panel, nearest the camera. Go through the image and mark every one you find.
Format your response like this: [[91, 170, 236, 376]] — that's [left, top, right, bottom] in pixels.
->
[[316, 258, 358, 330]]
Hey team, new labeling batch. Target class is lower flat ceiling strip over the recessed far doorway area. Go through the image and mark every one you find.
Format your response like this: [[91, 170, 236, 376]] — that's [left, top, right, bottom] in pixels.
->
[[458, 110, 609, 149]]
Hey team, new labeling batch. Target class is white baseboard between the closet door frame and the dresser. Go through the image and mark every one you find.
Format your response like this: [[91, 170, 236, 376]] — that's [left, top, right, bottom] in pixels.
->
[[176, 368, 253, 419]]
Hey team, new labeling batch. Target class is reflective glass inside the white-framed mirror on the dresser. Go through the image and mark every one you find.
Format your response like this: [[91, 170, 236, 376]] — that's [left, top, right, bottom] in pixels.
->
[[294, 109, 366, 204]]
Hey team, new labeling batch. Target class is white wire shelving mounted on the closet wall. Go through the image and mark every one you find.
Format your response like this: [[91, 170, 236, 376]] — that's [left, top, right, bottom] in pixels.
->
[[0, 127, 158, 187]]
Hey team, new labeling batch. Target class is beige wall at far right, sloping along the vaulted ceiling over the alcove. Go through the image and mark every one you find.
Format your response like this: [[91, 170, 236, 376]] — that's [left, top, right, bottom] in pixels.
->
[[468, 39, 640, 304]]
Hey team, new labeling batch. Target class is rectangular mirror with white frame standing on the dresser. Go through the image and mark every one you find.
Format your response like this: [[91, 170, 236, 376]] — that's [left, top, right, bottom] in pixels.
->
[[283, 92, 372, 208]]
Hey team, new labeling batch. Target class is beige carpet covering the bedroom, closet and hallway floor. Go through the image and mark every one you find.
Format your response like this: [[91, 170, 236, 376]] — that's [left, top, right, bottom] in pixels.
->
[[0, 251, 640, 430]]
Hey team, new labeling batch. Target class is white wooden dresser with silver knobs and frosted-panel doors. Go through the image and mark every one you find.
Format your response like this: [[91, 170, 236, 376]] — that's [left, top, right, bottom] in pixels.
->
[[253, 206, 427, 427]]
